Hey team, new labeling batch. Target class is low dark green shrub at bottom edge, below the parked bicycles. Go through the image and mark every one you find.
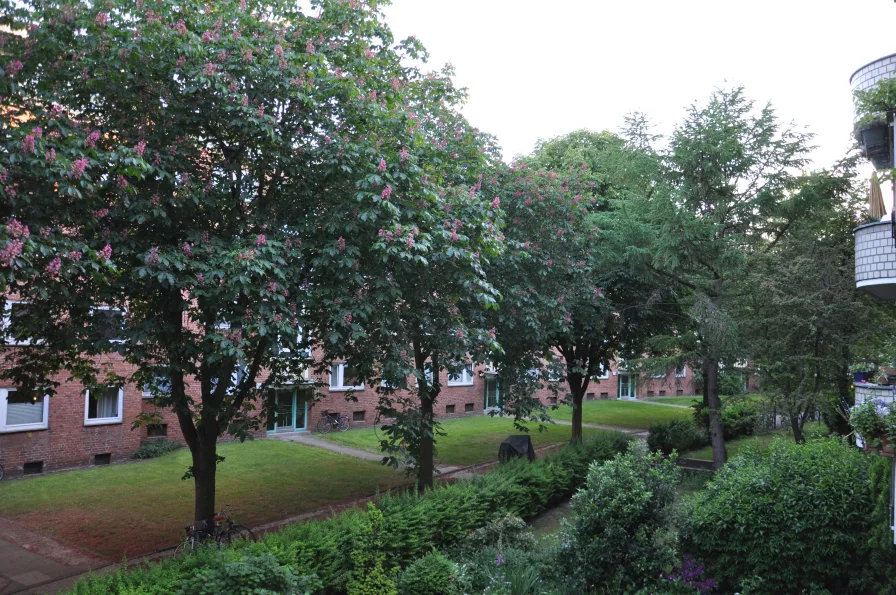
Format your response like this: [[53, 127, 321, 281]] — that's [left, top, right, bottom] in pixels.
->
[[179, 552, 322, 595]]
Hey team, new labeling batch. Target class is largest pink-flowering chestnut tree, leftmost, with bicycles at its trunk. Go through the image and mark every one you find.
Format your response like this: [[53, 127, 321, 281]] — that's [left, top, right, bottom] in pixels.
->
[[0, 0, 466, 521]]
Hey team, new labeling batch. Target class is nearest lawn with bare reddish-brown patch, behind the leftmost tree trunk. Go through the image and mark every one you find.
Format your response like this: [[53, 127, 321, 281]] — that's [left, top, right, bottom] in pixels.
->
[[0, 440, 408, 560]]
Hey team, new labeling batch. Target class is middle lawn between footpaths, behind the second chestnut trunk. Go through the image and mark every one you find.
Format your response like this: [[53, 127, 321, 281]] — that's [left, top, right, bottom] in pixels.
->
[[314, 414, 608, 466]]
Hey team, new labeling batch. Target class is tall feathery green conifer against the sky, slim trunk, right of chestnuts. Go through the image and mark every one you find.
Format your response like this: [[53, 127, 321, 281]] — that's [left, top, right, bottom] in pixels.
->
[[603, 88, 811, 467]]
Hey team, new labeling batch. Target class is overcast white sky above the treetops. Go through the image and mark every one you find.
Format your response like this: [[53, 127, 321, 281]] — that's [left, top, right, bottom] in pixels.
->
[[385, 0, 896, 168]]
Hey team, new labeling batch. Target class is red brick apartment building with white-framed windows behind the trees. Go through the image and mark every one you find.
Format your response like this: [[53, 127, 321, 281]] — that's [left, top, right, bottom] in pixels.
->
[[0, 314, 698, 476]]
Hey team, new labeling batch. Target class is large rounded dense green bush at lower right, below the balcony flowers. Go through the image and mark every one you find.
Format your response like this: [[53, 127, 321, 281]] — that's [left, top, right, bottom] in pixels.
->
[[682, 440, 873, 594]]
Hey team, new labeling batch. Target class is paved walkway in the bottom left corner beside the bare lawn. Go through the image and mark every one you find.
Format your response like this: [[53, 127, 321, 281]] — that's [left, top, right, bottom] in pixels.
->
[[0, 519, 109, 595]]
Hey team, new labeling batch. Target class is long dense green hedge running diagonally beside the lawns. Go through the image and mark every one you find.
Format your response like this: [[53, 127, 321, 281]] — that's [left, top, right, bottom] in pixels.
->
[[72, 433, 628, 595]]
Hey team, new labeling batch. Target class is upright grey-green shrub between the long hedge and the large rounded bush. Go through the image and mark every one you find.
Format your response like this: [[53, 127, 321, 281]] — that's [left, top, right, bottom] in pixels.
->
[[557, 442, 678, 593]]
